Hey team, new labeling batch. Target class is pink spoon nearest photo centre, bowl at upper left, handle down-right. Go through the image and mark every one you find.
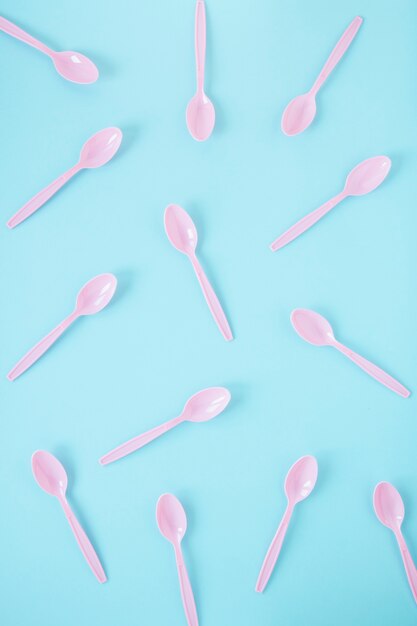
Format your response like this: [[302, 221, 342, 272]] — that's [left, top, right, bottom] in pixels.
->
[[165, 204, 233, 341]]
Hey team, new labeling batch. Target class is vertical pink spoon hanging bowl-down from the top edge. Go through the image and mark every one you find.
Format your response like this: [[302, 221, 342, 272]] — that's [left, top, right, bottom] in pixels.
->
[[186, 0, 216, 141]]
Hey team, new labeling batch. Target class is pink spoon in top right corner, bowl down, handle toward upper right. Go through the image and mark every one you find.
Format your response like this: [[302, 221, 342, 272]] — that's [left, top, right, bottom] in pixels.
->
[[281, 16, 363, 135]]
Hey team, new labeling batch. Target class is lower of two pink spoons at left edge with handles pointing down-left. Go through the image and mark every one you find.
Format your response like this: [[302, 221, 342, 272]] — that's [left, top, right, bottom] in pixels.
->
[[7, 274, 117, 380]]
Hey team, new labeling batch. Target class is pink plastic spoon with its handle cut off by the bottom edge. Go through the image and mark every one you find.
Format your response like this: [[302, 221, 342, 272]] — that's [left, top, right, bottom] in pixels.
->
[[156, 493, 198, 626]]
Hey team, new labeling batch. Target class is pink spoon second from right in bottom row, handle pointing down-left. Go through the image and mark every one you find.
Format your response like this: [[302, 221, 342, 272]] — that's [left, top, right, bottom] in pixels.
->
[[255, 456, 318, 592]]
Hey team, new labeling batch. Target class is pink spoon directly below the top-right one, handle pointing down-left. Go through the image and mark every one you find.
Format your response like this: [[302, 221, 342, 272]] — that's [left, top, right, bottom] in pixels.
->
[[270, 156, 391, 252]]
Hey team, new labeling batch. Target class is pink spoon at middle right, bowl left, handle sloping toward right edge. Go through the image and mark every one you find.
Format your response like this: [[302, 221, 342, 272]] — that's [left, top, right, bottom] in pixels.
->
[[291, 309, 410, 398]]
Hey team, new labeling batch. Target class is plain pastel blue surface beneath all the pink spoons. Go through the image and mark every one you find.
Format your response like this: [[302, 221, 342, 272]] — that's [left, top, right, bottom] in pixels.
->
[[0, 0, 417, 626]]
